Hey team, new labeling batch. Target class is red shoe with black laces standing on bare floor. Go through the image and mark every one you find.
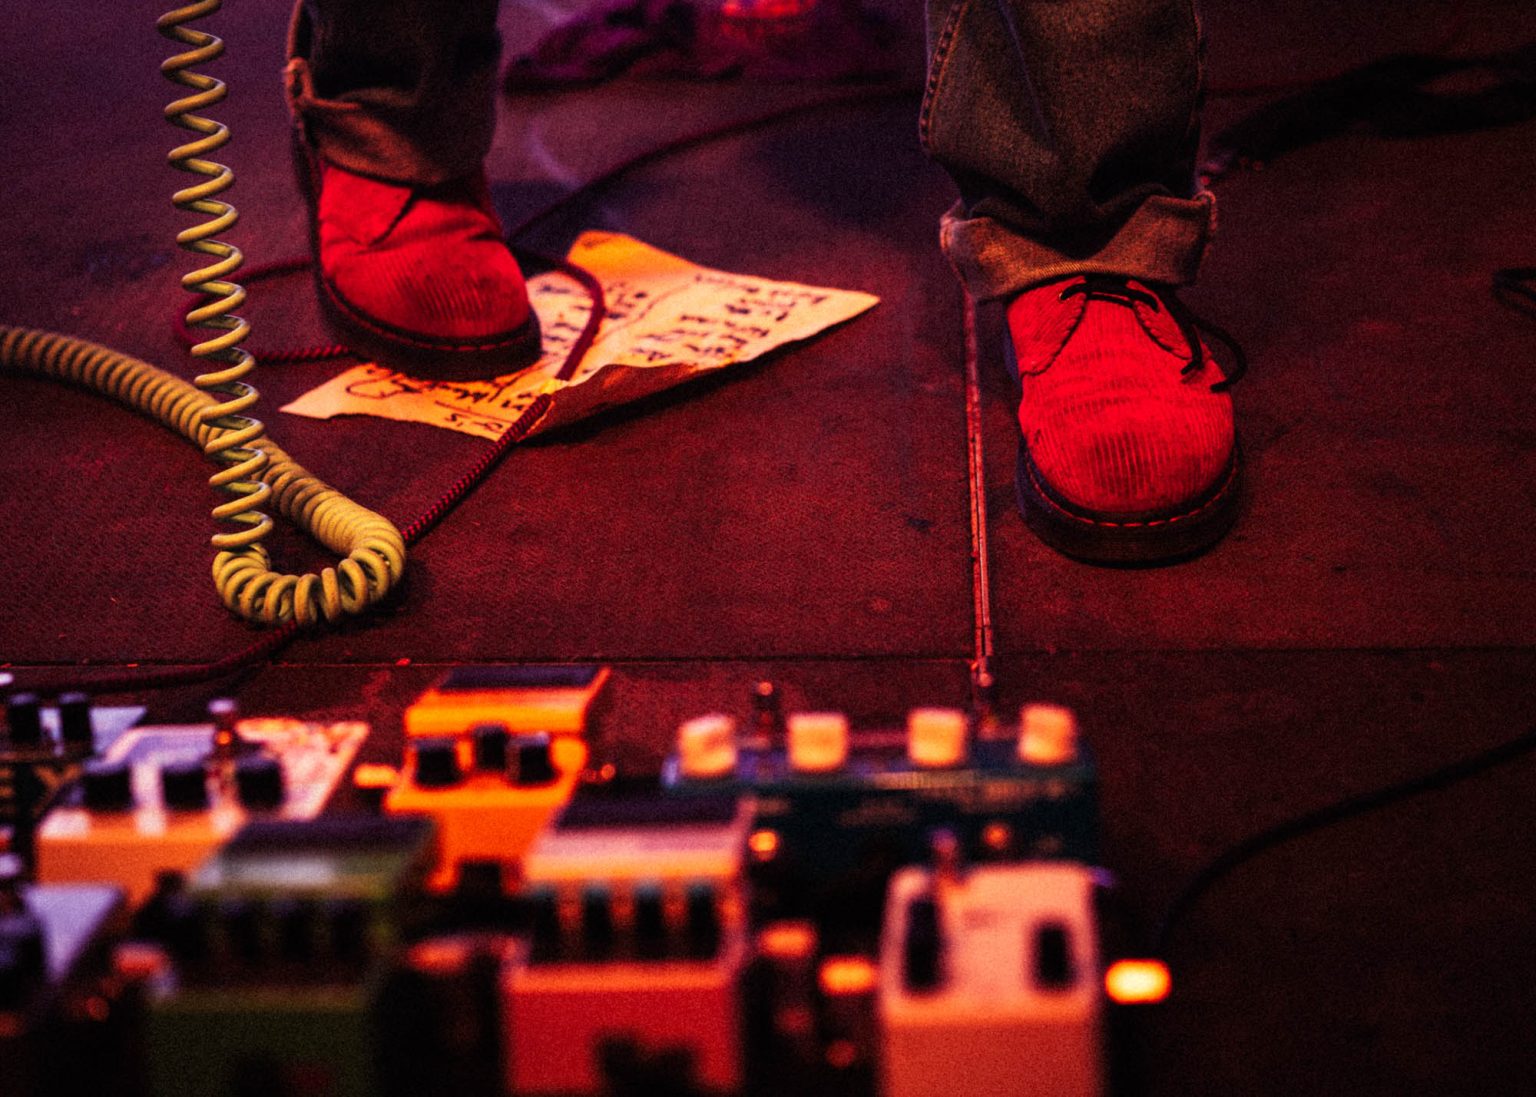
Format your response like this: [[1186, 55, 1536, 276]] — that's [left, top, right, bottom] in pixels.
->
[[1008, 275, 1243, 564]]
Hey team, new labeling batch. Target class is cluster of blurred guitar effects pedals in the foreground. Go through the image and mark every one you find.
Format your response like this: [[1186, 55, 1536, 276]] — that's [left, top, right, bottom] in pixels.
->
[[0, 667, 1166, 1097]]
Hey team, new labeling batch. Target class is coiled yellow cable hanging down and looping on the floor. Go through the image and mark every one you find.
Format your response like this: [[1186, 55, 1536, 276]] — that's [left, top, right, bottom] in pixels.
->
[[0, 0, 406, 625]]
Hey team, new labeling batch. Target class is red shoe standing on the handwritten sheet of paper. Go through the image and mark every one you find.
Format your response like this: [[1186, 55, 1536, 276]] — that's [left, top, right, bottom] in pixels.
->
[[301, 149, 539, 379]]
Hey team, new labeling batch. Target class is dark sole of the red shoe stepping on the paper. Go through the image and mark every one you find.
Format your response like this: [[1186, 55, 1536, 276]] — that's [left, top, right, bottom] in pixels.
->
[[292, 131, 544, 381]]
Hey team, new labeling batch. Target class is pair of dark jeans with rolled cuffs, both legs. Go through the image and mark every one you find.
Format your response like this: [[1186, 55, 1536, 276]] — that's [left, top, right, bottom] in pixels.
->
[[287, 0, 1215, 300]]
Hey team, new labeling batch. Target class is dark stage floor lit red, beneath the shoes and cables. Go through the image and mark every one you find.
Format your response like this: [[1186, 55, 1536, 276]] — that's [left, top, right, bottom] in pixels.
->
[[0, 0, 1536, 1097]]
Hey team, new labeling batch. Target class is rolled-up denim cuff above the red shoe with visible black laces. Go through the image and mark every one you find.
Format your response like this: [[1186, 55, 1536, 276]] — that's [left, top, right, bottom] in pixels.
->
[[938, 191, 1217, 301]]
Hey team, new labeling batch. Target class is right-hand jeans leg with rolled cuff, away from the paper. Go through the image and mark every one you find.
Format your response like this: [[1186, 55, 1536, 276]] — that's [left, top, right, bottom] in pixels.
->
[[919, 0, 1215, 300]]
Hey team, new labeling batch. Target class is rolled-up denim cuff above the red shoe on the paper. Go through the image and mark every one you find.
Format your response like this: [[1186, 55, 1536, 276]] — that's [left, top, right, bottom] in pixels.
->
[[283, 5, 496, 186]]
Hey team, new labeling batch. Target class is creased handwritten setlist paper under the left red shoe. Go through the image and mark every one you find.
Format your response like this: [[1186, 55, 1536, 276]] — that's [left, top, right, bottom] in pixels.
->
[[283, 232, 879, 438]]
